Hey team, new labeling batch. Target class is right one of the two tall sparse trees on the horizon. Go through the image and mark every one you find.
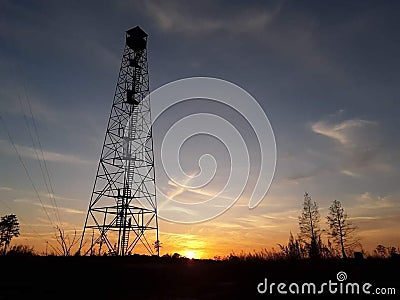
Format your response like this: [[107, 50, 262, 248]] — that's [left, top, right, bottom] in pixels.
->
[[326, 200, 359, 258]]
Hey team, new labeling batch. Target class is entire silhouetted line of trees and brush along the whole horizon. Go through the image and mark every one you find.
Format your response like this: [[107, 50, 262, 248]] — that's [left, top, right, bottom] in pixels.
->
[[0, 193, 400, 260]]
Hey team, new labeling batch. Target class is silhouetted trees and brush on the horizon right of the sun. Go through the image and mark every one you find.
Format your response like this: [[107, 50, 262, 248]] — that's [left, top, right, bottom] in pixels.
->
[[220, 193, 400, 260]]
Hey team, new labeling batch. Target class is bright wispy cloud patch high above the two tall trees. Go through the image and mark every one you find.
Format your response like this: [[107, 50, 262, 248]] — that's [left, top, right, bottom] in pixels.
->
[[294, 111, 391, 179]]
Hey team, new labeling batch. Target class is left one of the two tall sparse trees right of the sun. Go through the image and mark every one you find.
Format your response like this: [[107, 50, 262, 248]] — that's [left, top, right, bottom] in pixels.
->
[[299, 193, 321, 258]]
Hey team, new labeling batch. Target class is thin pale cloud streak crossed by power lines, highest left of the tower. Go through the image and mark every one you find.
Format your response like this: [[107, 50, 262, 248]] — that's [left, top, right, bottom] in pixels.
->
[[0, 140, 92, 164]]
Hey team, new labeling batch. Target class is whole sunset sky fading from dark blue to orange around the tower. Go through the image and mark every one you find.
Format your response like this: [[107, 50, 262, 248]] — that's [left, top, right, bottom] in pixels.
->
[[0, 0, 400, 258]]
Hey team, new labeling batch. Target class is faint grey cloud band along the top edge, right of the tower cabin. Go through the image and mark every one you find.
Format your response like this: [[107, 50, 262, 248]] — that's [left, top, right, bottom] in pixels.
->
[[139, 0, 348, 81]]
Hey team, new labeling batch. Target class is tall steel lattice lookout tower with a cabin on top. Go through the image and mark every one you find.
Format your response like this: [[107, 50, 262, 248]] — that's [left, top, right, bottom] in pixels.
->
[[80, 26, 159, 256]]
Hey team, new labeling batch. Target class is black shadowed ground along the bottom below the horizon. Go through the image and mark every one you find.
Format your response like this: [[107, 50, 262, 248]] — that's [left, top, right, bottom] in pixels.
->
[[0, 256, 400, 299]]
